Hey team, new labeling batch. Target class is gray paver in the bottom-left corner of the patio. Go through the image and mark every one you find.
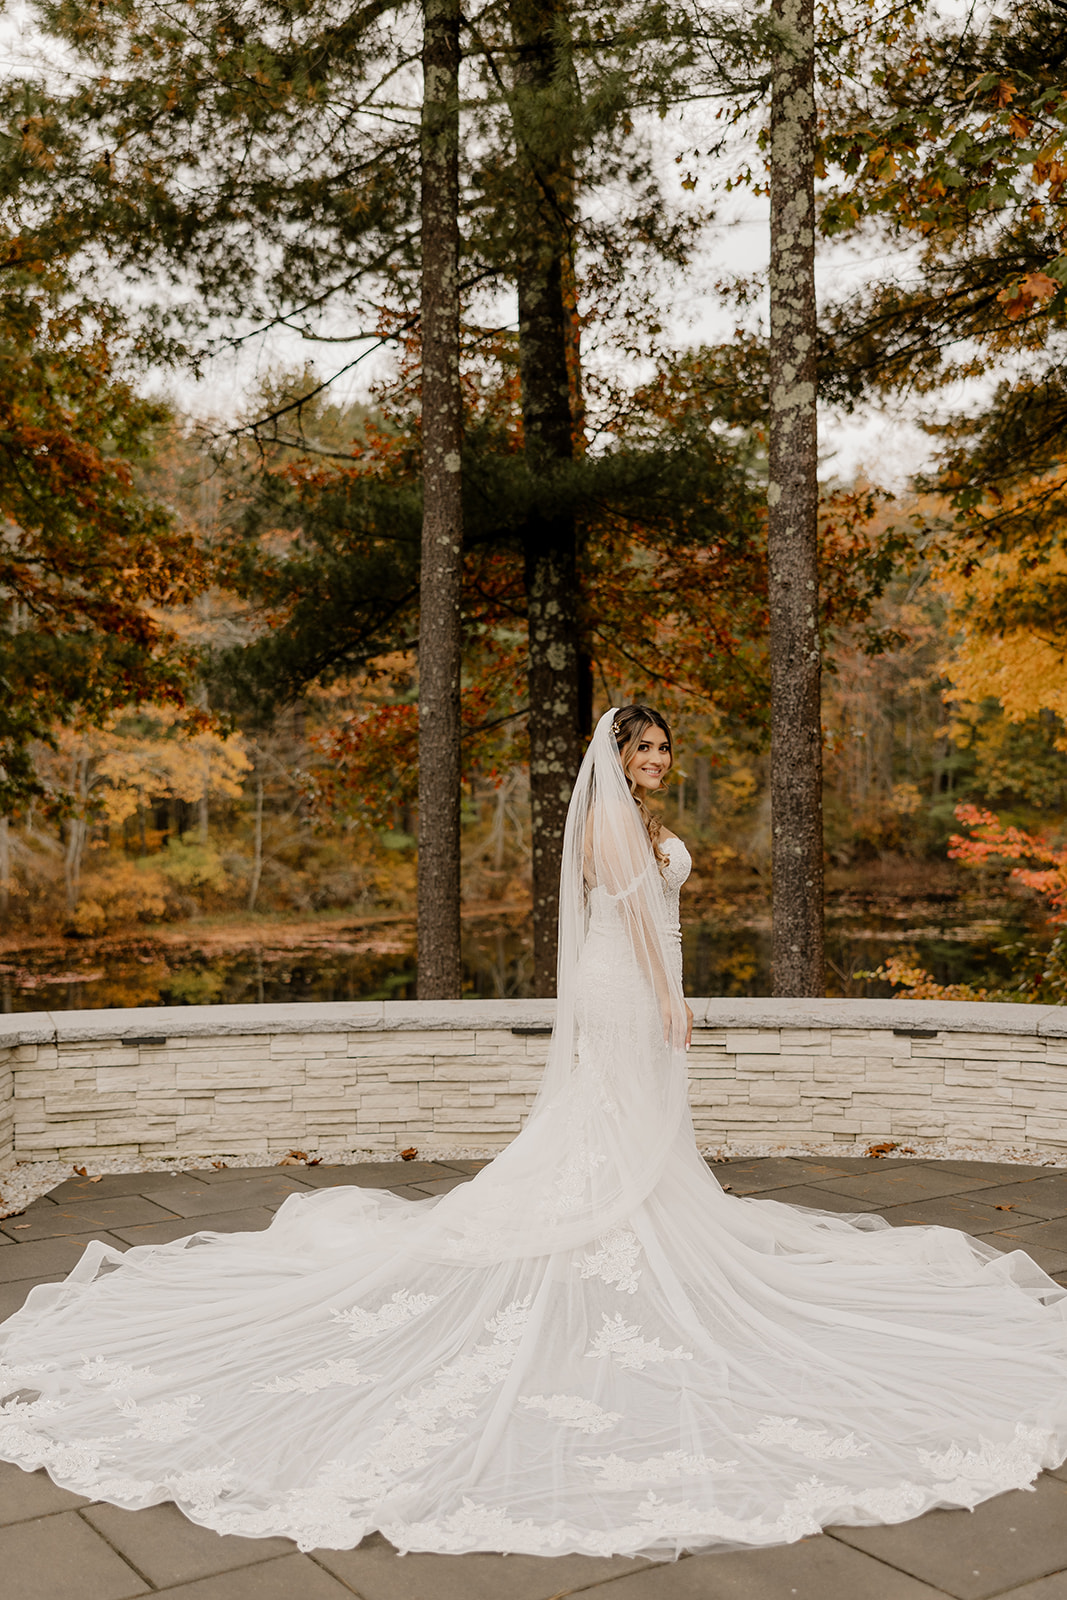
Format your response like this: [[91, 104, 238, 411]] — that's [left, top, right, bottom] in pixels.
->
[[0, 1510, 149, 1600]]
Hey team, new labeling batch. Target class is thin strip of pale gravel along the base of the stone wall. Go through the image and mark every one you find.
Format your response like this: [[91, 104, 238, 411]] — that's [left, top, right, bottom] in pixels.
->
[[0, 1139, 1067, 1218]]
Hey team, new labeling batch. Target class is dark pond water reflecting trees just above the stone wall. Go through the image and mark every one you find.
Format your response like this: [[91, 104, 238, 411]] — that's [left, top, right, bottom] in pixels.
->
[[0, 890, 1048, 1011]]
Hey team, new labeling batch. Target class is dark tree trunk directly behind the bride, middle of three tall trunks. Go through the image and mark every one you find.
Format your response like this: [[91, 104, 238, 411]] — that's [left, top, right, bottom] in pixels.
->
[[515, 0, 579, 995]]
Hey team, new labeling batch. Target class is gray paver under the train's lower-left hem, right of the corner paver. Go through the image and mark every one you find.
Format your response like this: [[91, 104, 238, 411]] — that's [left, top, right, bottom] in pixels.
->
[[83, 1502, 293, 1589]]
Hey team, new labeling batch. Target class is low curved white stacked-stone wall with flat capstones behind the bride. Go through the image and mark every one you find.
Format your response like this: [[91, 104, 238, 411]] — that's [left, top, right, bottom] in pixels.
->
[[0, 1000, 1067, 1162]]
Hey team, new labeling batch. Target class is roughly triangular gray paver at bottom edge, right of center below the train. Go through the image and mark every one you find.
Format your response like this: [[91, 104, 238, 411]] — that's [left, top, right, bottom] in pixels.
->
[[605, 1536, 944, 1600]]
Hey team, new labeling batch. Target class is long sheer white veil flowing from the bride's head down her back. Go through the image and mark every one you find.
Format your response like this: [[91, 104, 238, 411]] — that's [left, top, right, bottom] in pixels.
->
[[404, 707, 694, 1262]]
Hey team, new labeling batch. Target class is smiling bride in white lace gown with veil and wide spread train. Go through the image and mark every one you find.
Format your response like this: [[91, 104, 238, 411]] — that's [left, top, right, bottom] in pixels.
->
[[0, 706, 1067, 1557]]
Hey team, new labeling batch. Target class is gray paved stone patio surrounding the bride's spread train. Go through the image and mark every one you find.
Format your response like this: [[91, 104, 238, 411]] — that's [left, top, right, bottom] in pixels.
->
[[0, 1157, 1067, 1600]]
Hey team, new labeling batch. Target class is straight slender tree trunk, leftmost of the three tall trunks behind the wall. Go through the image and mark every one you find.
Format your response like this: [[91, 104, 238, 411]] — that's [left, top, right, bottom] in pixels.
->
[[418, 0, 462, 1000]]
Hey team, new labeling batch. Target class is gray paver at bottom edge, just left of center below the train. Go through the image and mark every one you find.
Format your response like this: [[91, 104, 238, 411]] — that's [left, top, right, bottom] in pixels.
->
[[315, 1534, 648, 1600]]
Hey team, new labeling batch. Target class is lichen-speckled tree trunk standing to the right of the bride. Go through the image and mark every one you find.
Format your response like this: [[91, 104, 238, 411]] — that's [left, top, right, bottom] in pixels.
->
[[768, 0, 825, 995]]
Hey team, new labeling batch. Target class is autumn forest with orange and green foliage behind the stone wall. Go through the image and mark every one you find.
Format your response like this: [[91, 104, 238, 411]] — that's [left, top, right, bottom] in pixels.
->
[[0, 0, 1067, 1008]]
